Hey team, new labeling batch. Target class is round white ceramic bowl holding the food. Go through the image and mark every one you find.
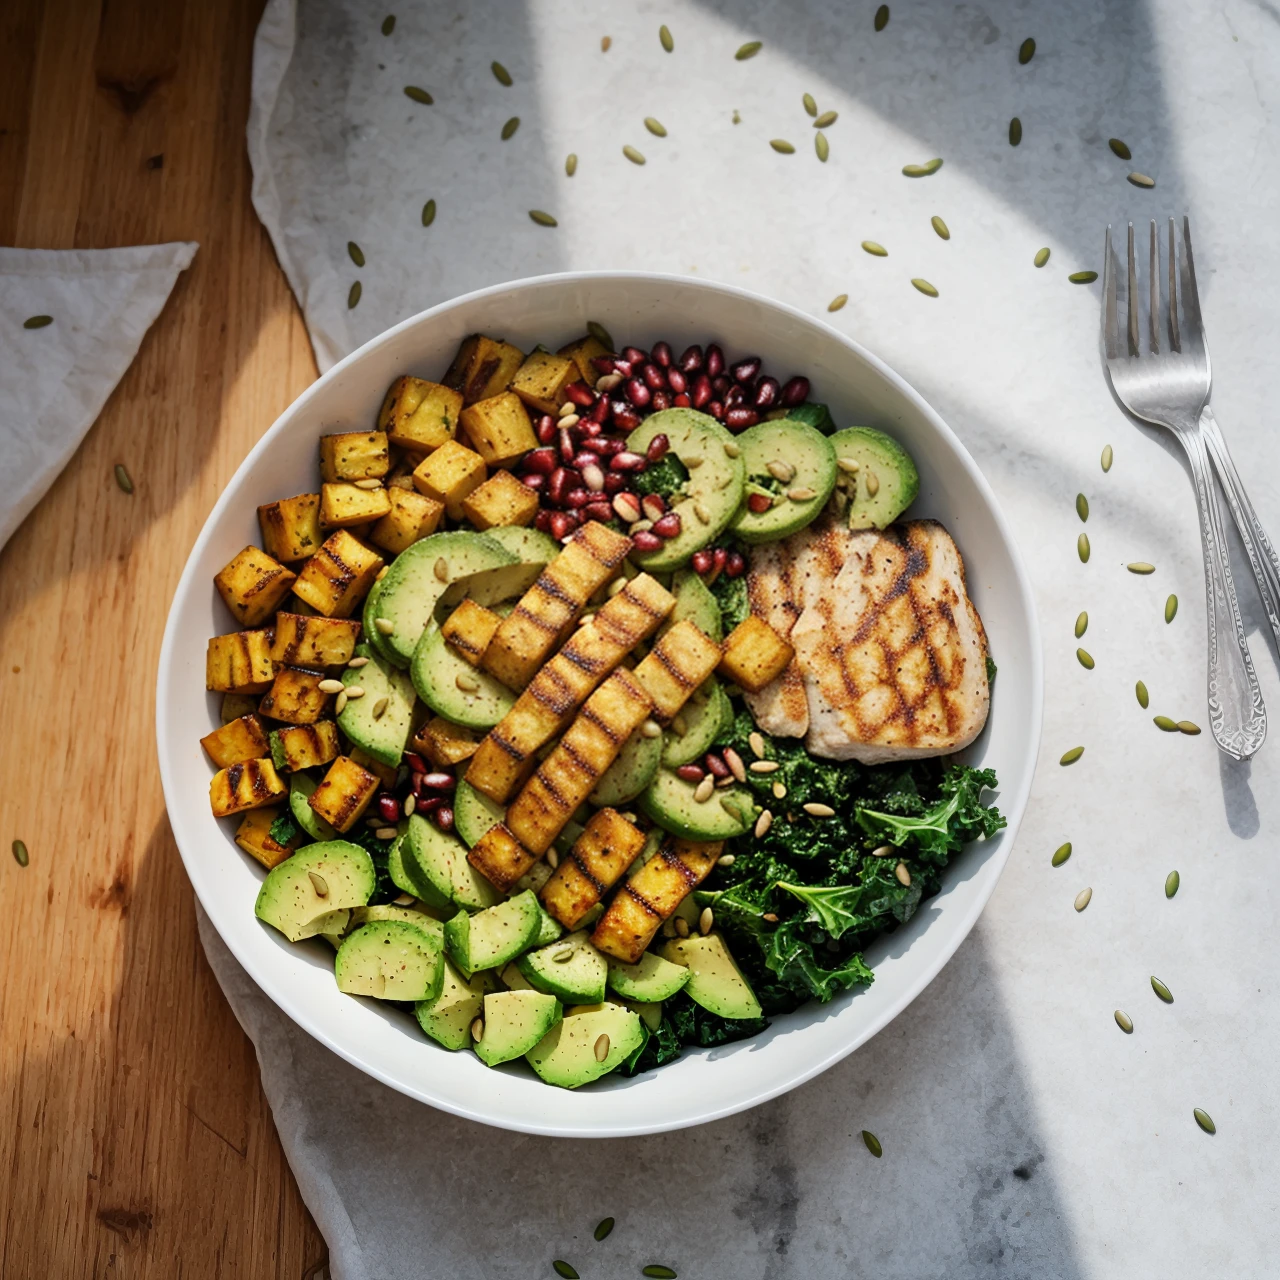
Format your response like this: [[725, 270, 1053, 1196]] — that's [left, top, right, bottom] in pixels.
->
[[156, 273, 1042, 1138]]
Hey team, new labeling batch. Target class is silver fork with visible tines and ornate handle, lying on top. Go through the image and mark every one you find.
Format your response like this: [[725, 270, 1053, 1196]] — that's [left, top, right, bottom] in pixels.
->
[[1102, 219, 1267, 760]]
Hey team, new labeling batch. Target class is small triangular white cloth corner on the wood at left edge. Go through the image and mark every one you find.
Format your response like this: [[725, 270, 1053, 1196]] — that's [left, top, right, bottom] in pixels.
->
[[0, 242, 198, 547]]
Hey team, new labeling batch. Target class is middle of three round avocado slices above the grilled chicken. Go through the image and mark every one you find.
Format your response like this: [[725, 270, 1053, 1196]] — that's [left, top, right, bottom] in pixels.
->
[[733, 417, 837, 543]]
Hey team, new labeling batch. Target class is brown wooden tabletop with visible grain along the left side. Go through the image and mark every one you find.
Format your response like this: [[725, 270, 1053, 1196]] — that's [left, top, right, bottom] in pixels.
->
[[0, 0, 324, 1280]]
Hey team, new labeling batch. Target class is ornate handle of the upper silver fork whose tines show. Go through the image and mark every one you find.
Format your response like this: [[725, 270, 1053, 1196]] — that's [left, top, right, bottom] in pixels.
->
[[1178, 424, 1267, 760]]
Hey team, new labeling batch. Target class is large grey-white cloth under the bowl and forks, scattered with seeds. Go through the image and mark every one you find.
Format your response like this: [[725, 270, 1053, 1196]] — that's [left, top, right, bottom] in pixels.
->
[[205, 0, 1280, 1280]]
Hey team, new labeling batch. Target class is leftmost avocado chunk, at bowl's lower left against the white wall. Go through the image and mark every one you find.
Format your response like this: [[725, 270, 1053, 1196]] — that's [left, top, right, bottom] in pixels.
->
[[253, 840, 376, 942]]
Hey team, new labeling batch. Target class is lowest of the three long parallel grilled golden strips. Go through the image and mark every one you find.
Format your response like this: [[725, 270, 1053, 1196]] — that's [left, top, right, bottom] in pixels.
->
[[507, 668, 653, 856]]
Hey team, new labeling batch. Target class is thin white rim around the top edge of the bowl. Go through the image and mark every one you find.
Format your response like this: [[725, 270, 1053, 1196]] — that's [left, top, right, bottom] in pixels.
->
[[156, 269, 1044, 1138]]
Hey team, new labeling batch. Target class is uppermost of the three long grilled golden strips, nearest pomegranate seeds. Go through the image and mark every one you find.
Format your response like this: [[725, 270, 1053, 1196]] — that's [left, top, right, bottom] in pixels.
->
[[483, 521, 631, 689]]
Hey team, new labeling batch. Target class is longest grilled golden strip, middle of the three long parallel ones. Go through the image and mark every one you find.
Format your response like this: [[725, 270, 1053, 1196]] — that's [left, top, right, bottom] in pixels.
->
[[467, 573, 676, 804]]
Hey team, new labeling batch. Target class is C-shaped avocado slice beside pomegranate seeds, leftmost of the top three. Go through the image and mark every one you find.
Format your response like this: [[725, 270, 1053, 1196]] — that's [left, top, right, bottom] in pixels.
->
[[627, 408, 746, 573]]
